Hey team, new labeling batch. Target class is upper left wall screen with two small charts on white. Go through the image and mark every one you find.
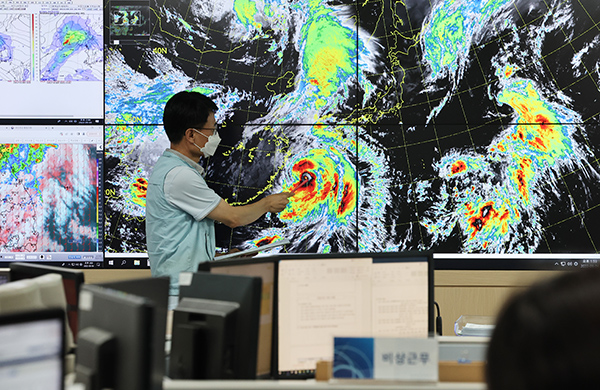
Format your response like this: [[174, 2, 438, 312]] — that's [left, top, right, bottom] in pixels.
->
[[0, 0, 104, 124]]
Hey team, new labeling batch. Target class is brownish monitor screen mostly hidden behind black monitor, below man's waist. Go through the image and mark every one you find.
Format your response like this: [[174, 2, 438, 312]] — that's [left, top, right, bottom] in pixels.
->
[[204, 257, 277, 378]]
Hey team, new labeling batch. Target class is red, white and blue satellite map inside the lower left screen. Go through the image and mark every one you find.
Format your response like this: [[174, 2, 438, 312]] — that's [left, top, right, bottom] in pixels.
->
[[0, 144, 98, 252]]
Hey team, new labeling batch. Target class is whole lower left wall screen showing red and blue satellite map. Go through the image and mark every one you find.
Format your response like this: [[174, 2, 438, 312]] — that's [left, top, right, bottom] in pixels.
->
[[0, 125, 103, 267]]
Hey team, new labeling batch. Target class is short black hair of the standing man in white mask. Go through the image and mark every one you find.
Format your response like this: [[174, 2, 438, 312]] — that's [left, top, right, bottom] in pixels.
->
[[163, 91, 218, 144]]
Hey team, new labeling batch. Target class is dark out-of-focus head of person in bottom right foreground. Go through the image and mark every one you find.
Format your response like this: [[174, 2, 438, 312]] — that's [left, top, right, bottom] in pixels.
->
[[486, 268, 600, 390]]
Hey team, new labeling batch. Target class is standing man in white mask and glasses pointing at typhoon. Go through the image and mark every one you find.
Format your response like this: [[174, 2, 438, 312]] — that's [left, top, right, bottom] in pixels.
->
[[146, 91, 292, 302]]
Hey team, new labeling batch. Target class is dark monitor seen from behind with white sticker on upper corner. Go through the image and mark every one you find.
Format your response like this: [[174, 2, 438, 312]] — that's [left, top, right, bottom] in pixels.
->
[[75, 285, 156, 390]]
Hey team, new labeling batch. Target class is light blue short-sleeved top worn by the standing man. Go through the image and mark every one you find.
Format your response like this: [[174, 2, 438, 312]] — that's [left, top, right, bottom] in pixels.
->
[[146, 149, 221, 295]]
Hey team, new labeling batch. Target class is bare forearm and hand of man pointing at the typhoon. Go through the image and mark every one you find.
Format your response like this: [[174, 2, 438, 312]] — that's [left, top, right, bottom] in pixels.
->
[[207, 192, 293, 228]]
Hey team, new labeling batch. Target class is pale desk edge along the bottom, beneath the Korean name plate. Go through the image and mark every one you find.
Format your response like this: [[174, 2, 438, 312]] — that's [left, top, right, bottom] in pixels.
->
[[163, 379, 486, 390]]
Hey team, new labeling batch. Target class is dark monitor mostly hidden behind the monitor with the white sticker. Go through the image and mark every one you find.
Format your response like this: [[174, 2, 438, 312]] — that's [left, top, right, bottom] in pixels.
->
[[97, 277, 169, 389]]
